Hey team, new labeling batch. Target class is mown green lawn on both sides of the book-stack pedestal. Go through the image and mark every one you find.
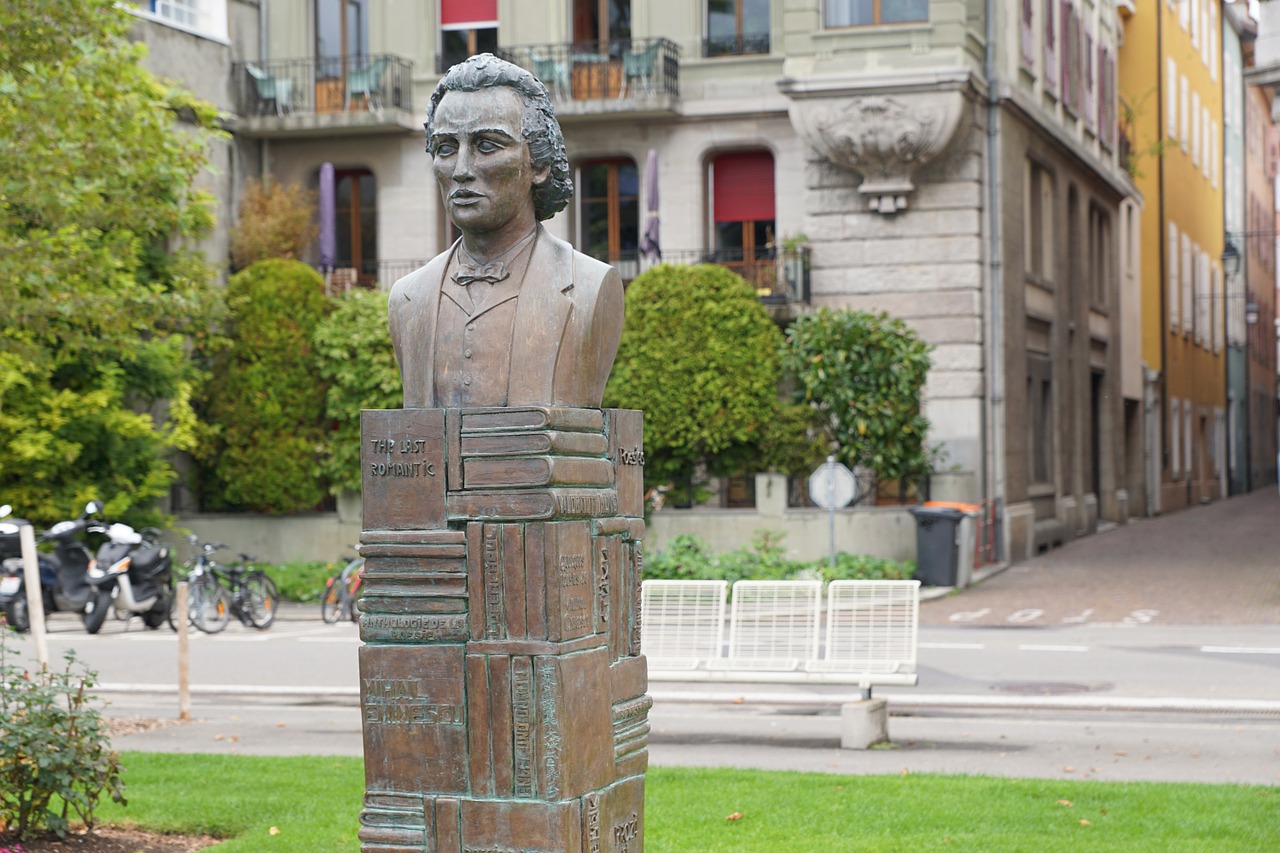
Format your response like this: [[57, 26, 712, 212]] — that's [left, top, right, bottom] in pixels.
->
[[100, 752, 1280, 853]]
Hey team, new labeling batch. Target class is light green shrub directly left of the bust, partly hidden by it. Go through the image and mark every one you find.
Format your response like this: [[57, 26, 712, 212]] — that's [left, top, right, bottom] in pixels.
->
[[315, 291, 403, 494]]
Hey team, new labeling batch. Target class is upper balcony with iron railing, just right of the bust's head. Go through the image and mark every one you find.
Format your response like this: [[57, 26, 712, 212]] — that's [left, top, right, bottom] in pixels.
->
[[498, 38, 680, 120]]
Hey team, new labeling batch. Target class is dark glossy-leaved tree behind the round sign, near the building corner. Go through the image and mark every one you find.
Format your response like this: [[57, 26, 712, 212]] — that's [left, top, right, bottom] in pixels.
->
[[783, 309, 932, 489]]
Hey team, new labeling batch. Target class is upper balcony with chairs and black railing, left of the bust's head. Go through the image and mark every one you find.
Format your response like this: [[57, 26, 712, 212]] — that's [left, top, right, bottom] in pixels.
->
[[232, 54, 421, 137]]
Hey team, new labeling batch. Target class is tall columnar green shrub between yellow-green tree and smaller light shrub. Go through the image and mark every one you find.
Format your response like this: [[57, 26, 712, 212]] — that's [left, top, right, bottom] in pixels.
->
[[201, 260, 329, 514]]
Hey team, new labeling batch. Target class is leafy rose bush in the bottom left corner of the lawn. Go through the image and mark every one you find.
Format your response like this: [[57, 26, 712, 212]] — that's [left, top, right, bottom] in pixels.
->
[[0, 631, 124, 839]]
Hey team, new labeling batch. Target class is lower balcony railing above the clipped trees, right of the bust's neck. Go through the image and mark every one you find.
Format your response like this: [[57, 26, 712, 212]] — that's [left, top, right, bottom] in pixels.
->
[[603, 246, 809, 305]]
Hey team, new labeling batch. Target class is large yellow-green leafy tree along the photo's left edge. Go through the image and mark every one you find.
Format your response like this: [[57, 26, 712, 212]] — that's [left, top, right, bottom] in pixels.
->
[[0, 0, 218, 523]]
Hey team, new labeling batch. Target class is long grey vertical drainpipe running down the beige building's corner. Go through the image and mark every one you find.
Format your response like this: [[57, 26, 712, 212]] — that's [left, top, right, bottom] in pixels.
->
[[983, 0, 1009, 560]]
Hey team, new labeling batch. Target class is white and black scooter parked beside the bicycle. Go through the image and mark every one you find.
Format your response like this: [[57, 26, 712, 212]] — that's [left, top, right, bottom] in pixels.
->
[[84, 523, 173, 634]]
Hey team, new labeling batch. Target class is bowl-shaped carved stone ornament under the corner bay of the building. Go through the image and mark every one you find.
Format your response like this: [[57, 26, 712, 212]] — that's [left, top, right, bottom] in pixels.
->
[[791, 92, 965, 214]]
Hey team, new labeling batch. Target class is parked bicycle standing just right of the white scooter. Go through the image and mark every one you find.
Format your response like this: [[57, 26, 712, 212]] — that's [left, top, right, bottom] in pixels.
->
[[176, 535, 280, 634]]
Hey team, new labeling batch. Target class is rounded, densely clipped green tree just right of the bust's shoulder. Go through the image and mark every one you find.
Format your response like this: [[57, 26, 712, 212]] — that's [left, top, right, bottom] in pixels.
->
[[604, 264, 798, 501]]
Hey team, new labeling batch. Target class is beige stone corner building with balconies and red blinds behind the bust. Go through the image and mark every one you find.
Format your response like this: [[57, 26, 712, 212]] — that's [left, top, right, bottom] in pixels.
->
[[129, 0, 1143, 558]]
